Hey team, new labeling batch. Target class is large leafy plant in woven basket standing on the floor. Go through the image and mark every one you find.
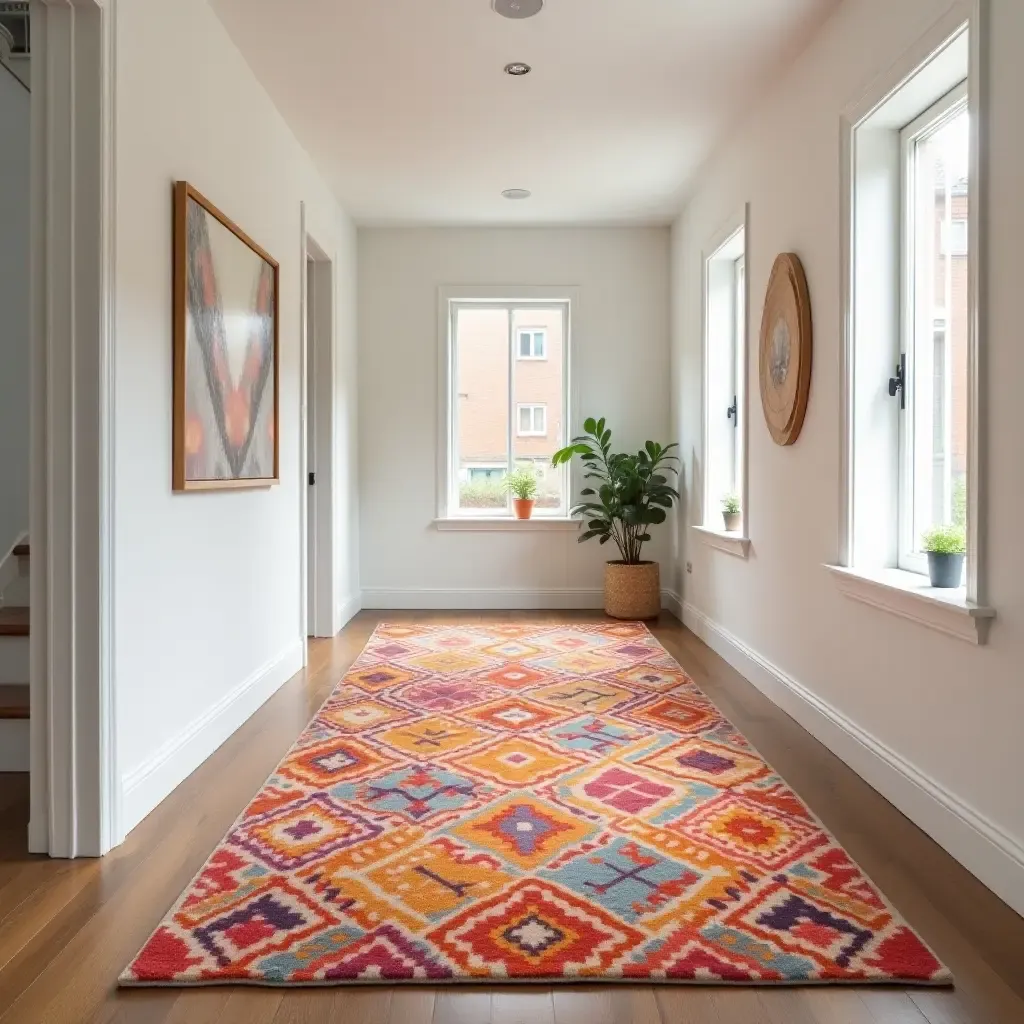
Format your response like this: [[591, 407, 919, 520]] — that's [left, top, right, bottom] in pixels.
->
[[551, 417, 679, 618]]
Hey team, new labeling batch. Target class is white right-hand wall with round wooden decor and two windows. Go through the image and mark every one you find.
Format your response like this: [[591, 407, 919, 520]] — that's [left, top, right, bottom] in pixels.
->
[[673, 0, 1024, 912]]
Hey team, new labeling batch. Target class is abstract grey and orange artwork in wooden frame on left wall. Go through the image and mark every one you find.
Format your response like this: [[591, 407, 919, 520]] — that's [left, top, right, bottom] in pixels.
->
[[172, 181, 281, 490]]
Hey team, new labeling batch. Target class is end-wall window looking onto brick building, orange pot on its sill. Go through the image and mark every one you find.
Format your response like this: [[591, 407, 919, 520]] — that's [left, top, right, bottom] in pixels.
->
[[438, 298, 569, 519]]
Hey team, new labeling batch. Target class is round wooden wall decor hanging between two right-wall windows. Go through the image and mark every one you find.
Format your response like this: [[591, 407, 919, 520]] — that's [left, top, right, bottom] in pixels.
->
[[761, 253, 812, 444]]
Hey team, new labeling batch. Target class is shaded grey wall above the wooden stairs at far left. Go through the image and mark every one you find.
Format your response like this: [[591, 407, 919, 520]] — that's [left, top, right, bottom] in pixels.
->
[[0, 67, 30, 559]]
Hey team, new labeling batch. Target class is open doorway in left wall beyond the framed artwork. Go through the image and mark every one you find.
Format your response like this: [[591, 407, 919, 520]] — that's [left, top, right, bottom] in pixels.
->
[[303, 234, 337, 637]]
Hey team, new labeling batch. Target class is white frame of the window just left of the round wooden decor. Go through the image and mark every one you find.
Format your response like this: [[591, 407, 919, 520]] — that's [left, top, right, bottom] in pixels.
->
[[693, 204, 751, 558]]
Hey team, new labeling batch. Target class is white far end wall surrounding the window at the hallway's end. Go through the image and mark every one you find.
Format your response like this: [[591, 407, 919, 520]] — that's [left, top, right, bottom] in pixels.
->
[[358, 228, 671, 607]]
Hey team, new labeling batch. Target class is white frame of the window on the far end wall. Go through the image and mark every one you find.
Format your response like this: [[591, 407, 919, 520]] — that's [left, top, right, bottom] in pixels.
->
[[434, 286, 582, 530]]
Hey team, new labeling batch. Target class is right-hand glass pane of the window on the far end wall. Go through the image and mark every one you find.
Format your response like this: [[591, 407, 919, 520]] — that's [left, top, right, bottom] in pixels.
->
[[512, 306, 566, 515]]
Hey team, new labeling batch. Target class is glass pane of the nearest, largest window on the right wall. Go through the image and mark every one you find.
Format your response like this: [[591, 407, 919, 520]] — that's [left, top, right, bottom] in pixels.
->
[[909, 109, 969, 550]]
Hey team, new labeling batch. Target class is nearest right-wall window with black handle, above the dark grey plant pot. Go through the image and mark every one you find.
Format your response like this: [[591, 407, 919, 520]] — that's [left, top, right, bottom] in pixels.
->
[[898, 87, 970, 572]]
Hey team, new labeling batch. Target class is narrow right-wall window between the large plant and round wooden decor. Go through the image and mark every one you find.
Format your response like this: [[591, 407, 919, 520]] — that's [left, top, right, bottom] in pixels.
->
[[702, 220, 746, 550]]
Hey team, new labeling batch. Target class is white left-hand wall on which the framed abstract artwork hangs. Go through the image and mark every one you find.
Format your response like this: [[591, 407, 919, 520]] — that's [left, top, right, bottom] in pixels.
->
[[114, 0, 358, 829]]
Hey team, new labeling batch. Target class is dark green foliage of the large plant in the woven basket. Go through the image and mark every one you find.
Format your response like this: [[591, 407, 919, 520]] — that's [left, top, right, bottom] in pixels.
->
[[551, 417, 679, 565]]
